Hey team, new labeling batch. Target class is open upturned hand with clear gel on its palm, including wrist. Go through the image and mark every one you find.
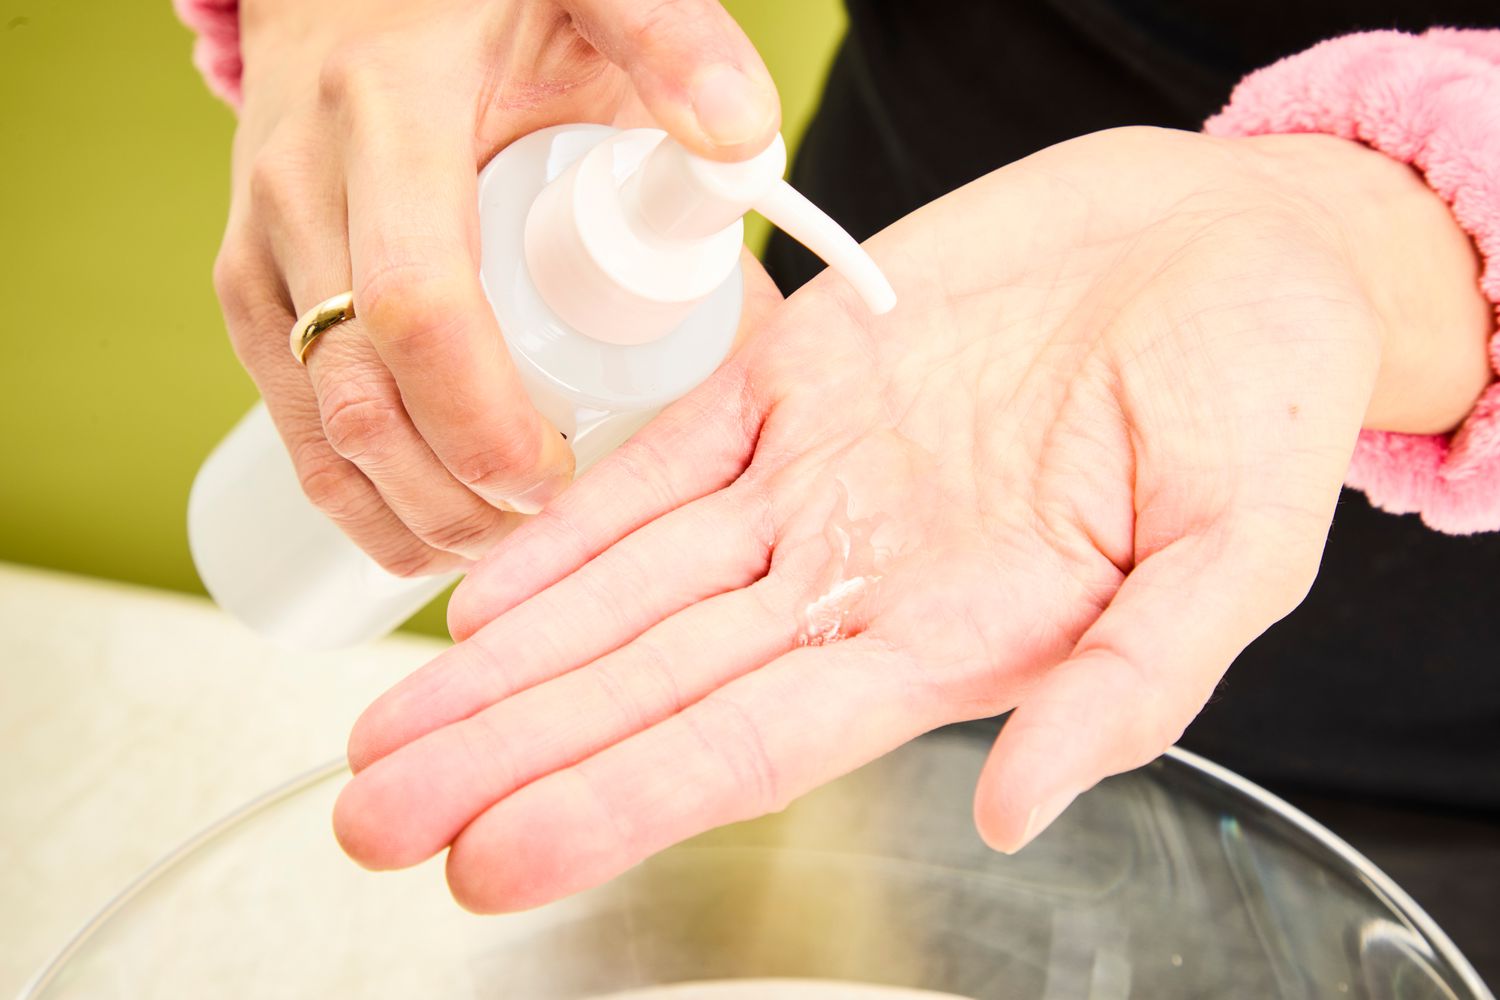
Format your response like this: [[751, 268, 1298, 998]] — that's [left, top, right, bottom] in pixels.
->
[[335, 129, 1488, 910]]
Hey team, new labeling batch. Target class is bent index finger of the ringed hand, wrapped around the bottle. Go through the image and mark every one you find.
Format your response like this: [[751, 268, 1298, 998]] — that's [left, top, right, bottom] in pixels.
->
[[347, 103, 573, 513]]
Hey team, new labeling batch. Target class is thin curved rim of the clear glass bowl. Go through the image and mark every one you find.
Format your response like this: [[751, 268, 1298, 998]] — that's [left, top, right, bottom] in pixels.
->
[[17, 747, 1496, 1000]]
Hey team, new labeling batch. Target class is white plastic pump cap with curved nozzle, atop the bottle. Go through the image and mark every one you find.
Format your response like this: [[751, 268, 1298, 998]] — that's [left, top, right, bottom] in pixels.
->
[[525, 129, 896, 345]]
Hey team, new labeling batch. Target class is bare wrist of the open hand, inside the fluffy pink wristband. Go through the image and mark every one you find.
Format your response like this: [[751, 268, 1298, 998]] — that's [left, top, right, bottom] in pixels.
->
[[1229, 133, 1494, 433]]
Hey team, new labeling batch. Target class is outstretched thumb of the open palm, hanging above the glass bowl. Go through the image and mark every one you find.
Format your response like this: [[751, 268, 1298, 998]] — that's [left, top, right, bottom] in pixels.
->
[[975, 521, 1322, 853]]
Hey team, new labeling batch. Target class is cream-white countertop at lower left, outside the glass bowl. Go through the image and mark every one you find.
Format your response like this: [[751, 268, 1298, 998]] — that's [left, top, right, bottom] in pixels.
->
[[0, 564, 444, 999]]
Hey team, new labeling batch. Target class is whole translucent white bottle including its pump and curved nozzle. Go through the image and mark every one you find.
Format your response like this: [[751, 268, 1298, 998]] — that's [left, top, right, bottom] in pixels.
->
[[188, 124, 896, 649]]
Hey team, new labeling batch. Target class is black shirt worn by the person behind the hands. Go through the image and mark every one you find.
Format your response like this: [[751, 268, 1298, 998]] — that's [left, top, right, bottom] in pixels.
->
[[767, 0, 1500, 977]]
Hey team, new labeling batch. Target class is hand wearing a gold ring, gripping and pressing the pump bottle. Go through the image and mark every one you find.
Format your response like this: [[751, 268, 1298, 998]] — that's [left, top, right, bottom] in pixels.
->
[[215, 0, 779, 576]]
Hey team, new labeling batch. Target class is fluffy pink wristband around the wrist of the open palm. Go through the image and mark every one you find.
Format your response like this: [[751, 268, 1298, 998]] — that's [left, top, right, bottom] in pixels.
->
[[1203, 28, 1500, 534]]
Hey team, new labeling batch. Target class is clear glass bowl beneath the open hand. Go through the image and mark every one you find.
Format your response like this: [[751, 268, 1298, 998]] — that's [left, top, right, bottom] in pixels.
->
[[23, 726, 1493, 1000]]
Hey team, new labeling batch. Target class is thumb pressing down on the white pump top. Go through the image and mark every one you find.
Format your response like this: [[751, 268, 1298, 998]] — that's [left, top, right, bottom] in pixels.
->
[[564, 0, 782, 160]]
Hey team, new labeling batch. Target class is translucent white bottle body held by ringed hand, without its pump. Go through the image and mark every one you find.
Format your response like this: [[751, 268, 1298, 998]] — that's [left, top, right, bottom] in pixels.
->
[[188, 124, 744, 649]]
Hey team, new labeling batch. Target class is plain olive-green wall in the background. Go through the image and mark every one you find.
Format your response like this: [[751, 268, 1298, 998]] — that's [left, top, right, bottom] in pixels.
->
[[0, 0, 843, 633]]
